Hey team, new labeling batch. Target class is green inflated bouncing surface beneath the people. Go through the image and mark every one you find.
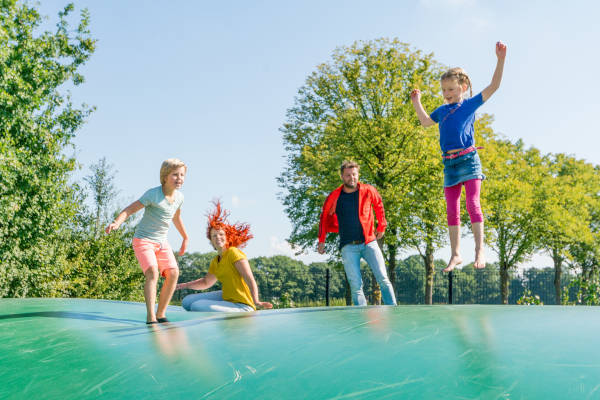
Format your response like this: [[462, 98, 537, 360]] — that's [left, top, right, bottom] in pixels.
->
[[0, 299, 600, 399]]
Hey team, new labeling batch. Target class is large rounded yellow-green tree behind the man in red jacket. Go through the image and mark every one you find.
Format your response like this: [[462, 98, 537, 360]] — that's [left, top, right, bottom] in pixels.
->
[[278, 39, 441, 296]]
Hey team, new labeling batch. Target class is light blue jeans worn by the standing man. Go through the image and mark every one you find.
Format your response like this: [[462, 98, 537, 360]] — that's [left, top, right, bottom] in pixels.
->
[[342, 240, 396, 306]]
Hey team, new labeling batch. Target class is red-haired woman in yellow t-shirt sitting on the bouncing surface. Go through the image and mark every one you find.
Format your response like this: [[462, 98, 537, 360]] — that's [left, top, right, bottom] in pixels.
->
[[177, 202, 273, 312]]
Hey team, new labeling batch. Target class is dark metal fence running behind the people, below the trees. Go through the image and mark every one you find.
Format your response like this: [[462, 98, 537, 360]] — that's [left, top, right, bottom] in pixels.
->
[[255, 268, 576, 305]]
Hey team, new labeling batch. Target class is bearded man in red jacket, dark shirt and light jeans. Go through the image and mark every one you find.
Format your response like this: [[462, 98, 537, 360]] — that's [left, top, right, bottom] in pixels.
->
[[318, 161, 396, 306]]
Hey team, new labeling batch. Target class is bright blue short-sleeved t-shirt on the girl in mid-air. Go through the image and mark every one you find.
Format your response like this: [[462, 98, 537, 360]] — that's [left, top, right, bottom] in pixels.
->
[[430, 93, 483, 152]]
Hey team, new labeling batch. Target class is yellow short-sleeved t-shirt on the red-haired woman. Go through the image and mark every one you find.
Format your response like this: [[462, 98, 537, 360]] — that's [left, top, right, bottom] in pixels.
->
[[208, 247, 256, 310]]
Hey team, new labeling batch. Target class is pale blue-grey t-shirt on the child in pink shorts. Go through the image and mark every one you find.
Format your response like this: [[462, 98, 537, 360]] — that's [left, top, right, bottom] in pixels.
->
[[133, 186, 183, 243]]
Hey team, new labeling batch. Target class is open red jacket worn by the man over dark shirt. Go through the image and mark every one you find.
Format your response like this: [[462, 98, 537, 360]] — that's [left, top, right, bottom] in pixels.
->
[[319, 182, 387, 243]]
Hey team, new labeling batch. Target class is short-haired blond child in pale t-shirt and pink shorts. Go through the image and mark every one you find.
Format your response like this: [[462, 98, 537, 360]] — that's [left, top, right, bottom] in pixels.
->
[[105, 158, 188, 324]]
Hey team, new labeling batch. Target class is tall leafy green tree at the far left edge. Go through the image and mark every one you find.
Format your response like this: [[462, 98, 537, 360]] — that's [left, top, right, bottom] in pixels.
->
[[0, 0, 95, 297]]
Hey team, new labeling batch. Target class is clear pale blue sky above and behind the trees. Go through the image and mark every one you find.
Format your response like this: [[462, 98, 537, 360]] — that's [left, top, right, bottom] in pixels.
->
[[40, 0, 600, 266]]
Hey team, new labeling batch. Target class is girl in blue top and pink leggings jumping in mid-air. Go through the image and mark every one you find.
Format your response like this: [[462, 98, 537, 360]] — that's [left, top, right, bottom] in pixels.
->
[[410, 42, 506, 272]]
